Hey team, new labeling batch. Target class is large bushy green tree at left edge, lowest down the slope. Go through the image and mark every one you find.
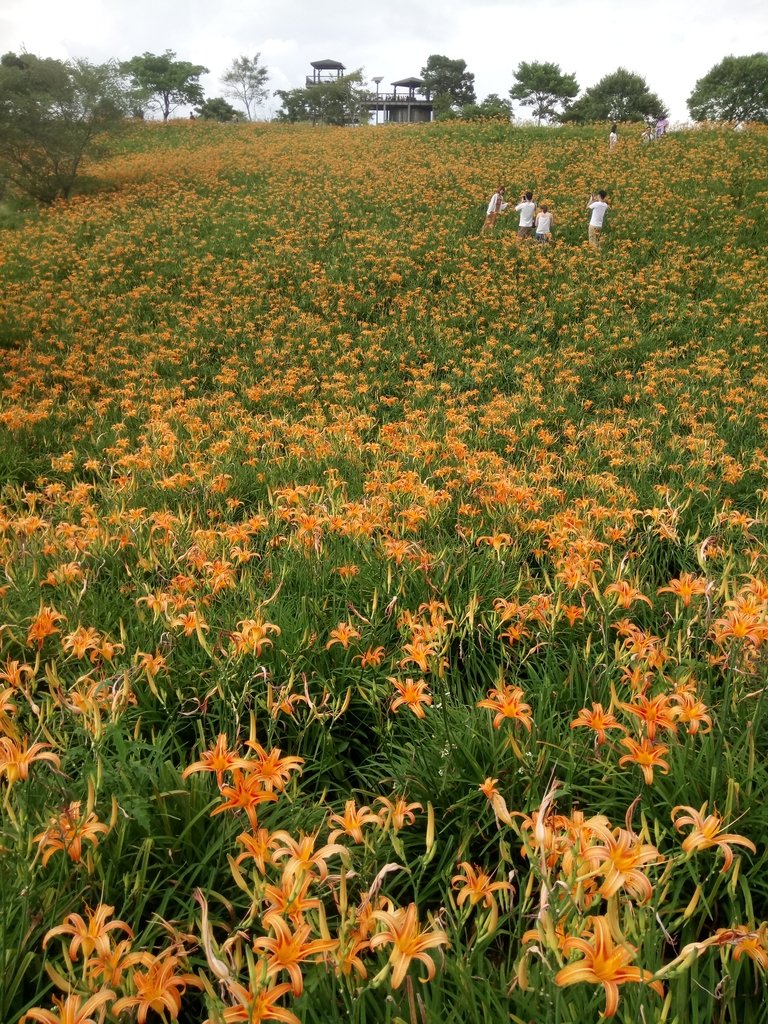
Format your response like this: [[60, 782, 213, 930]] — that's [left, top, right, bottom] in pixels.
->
[[0, 53, 126, 203]]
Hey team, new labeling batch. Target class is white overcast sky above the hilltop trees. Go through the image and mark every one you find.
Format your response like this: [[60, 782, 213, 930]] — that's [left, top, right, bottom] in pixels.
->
[[0, 0, 768, 121]]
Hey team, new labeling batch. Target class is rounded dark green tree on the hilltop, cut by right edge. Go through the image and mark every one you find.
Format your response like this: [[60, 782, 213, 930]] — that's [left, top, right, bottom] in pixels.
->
[[688, 53, 768, 124]]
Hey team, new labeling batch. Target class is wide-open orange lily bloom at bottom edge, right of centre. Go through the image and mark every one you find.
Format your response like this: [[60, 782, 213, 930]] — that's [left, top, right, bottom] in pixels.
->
[[555, 916, 664, 1017]]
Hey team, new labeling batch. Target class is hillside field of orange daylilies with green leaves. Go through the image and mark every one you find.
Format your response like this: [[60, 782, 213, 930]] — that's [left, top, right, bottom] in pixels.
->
[[0, 122, 768, 1024]]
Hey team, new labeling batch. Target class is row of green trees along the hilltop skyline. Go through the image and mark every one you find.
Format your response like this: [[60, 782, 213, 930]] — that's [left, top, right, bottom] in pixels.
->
[[0, 50, 768, 203]]
